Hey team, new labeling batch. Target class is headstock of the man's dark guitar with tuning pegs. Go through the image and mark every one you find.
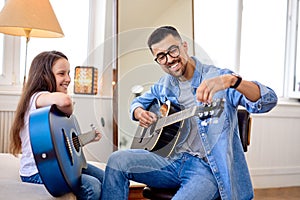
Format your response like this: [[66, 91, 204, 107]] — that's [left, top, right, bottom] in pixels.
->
[[195, 99, 225, 120]]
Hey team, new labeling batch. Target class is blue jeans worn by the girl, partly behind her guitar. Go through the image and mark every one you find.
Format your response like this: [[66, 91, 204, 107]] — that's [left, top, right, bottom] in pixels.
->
[[21, 164, 104, 200]]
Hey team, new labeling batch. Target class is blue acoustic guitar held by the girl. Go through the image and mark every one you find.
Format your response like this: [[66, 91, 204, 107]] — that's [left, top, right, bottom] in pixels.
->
[[29, 105, 96, 197]]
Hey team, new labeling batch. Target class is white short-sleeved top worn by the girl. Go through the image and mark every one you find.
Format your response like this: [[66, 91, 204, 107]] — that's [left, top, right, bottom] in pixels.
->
[[20, 91, 49, 176]]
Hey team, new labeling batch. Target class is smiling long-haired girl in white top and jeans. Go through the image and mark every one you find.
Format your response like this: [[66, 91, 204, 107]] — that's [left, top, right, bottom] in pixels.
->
[[10, 51, 104, 199]]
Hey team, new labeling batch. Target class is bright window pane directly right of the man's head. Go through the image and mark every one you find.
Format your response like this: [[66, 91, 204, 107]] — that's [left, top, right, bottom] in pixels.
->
[[194, 0, 239, 71]]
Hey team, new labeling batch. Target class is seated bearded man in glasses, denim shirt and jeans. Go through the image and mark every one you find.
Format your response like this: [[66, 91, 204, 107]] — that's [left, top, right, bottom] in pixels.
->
[[102, 26, 277, 200]]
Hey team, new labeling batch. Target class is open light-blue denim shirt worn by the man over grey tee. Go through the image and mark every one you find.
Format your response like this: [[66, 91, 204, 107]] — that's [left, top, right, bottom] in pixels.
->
[[130, 57, 277, 200]]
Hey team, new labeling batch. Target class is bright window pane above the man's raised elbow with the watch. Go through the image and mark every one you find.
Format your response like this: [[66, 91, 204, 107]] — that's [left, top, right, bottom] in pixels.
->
[[240, 0, 287, 96]]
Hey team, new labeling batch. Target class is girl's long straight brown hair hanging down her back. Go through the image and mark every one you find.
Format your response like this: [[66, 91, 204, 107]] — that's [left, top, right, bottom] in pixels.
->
[[9, 51, 68, 156]]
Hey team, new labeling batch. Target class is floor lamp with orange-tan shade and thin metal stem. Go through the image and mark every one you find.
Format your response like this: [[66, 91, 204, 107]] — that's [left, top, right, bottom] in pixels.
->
[[0, 0, 64, 86]]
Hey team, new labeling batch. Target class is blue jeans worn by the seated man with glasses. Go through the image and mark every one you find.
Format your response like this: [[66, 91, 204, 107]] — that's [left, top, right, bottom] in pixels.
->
[[101, 149, 219, 200]]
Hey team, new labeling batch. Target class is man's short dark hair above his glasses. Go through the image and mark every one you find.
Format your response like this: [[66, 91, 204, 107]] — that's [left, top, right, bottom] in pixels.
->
[[148, 26, 181, 52]]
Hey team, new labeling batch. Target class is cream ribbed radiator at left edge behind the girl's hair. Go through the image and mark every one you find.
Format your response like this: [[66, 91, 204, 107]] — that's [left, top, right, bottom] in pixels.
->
[[0, 111, 15, 153]]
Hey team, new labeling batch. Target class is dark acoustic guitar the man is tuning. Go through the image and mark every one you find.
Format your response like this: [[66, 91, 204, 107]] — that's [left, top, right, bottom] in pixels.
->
[[131, 99, 224, 157]]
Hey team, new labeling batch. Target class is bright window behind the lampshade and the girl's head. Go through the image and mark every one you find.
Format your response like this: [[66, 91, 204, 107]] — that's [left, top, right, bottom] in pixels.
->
[[20, 0, 89, 89]]
